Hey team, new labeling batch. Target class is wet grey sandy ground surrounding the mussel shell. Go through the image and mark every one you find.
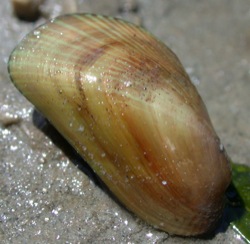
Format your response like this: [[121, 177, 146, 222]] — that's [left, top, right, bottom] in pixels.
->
[[0, 0, 250, 243]]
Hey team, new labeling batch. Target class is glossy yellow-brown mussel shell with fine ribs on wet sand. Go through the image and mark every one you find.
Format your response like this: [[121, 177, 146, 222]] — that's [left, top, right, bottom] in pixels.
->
[[9, 14, 231, 236]]
